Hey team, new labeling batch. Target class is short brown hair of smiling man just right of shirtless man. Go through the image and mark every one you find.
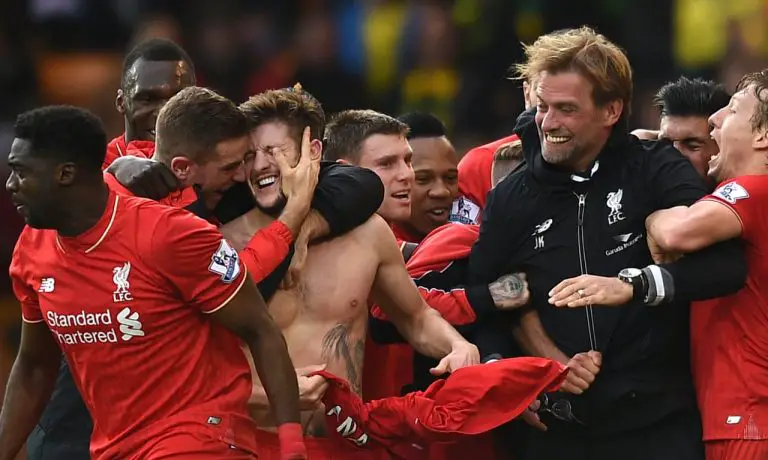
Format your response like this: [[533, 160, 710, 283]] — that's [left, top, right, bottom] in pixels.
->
[[323, 110, 408, 163]]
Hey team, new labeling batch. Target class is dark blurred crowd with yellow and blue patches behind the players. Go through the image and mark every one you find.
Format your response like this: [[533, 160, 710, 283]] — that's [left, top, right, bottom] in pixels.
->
[[0, 0, 768, 398]]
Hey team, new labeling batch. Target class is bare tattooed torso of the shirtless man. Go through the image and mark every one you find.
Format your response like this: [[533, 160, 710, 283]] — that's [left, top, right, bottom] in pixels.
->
[[222, 210, 378, 437]]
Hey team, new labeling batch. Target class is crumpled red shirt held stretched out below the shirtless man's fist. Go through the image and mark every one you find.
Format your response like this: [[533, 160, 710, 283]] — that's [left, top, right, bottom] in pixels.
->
[[312, 358, 568, 460]]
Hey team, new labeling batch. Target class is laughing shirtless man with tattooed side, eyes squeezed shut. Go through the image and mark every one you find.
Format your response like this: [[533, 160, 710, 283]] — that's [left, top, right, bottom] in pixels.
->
[[221, 89, 479, 459]]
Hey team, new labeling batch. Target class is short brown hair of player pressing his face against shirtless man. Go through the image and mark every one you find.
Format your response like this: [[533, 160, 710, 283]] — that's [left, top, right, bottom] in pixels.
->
[[155, 86, 248, 164]]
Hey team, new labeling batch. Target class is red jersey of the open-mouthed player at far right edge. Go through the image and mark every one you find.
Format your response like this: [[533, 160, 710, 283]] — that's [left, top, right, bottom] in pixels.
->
[[691, 176, 768, 441]]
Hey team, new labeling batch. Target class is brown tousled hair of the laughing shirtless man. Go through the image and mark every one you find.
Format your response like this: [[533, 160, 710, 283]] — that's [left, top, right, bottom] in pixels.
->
[[240, 83, 325, 145]]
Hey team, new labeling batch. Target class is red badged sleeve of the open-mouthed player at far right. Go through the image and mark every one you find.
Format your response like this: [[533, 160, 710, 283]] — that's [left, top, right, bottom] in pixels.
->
[[703, 176, 768, 242]]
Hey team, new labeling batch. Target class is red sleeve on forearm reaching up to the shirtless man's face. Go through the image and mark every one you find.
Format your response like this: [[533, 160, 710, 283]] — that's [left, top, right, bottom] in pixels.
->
[[240, 220, 293, 283]]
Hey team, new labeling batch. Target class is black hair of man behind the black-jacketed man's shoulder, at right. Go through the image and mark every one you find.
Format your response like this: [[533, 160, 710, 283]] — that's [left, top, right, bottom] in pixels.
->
[[653, 77, 731, 117]]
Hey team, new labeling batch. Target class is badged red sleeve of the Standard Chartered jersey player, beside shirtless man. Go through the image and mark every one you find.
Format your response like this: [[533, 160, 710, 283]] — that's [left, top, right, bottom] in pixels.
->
[[150, 208, 248, 313]]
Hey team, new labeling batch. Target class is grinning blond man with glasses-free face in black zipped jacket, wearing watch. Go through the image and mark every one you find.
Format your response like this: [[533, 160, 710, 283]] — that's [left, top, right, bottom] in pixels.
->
[[469, 28, 746, 460]]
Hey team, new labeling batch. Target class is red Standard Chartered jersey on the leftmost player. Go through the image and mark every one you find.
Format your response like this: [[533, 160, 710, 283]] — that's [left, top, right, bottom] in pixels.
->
[[10, 192, 256, 459]]
